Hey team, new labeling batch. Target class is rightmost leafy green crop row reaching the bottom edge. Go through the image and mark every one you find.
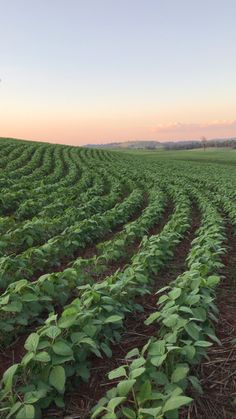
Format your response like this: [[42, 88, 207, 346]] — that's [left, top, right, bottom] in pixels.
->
[[91, 191, 225, 419]]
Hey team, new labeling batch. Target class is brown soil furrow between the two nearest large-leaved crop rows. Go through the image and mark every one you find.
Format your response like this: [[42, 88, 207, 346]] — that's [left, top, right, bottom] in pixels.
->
[[44, 208, 200, 419]]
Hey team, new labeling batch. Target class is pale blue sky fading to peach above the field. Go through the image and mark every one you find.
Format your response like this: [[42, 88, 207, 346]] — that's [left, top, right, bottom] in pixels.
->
[[0, 0, 236, 145]]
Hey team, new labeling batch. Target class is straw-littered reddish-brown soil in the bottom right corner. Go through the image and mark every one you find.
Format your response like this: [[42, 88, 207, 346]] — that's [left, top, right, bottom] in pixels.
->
[[181, 224, 236, 419]]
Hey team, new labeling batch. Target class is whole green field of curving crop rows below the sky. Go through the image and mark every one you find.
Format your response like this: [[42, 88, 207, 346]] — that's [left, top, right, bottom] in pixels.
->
[[0, 139, 236, 419]]
